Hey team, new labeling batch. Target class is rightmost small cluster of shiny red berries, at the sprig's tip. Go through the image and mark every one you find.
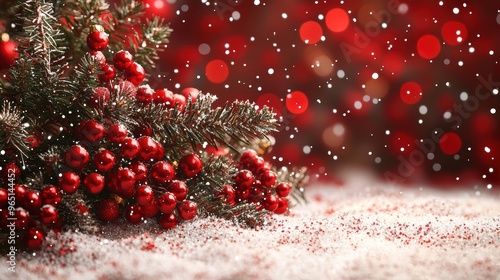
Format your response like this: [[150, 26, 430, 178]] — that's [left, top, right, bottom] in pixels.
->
[[221, 150, 292, 214]]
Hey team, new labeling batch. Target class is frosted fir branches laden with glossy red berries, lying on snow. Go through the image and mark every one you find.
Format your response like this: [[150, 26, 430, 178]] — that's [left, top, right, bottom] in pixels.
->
[[0, 1, 307, 249]]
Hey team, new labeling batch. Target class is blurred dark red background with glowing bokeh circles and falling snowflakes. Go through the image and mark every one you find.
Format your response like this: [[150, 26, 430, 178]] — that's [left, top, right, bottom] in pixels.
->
[[2, 0, 500, 190]]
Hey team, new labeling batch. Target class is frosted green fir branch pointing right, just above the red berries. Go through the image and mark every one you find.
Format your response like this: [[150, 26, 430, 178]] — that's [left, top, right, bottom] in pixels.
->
[[141, 94, 277, 153]]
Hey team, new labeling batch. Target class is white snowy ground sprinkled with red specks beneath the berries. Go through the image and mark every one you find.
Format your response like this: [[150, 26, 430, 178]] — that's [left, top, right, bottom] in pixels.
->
[[0, 178, 500, 279]]
